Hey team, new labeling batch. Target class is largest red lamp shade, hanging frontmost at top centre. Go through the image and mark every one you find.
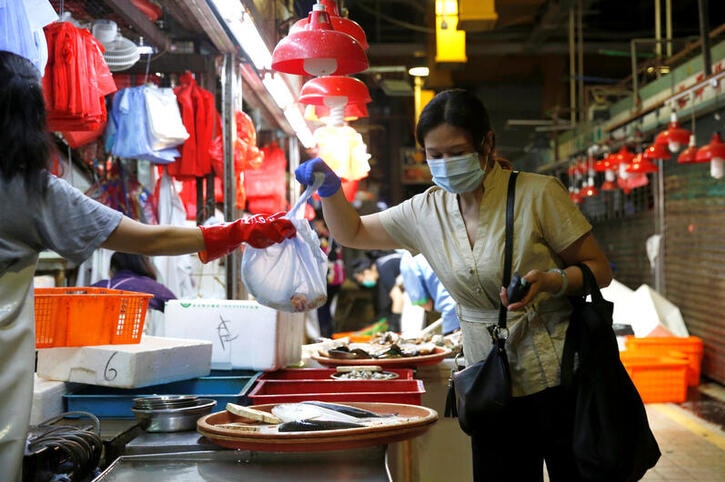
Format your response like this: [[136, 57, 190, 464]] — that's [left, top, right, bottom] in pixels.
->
[[272, 3, 368, 77]]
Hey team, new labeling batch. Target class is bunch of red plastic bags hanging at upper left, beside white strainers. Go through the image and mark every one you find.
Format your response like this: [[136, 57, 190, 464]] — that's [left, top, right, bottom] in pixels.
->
[[43, 22, 117, 131]]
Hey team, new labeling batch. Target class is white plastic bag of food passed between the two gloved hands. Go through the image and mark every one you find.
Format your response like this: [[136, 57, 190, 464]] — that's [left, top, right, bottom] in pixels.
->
[[242, 176, 327, 312]]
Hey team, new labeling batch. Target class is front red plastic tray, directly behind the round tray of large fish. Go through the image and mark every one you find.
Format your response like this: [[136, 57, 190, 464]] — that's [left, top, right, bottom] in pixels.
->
[[248, 379, 425, 405]]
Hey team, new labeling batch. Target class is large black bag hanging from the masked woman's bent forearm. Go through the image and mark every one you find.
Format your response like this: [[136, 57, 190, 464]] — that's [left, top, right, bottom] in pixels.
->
[[561, 264, 660, 481]]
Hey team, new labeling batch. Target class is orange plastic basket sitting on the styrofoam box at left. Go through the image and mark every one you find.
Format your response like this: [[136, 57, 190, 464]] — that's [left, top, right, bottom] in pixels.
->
[[35, 287, 153, 348]]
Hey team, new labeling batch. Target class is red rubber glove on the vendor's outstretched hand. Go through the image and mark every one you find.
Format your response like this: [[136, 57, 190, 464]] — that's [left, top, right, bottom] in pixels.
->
[[199, 212, 297, 263]]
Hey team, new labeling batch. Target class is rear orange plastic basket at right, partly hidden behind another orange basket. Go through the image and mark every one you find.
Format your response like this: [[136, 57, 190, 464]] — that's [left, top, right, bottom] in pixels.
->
[[624, 336, 702, 387]]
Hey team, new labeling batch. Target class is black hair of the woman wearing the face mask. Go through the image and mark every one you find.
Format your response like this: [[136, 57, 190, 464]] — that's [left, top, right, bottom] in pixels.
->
[[415, 89, 495, 152]]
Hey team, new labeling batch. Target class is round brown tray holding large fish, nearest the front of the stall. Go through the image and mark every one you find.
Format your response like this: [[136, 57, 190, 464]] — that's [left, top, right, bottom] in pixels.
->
[[196, 402, 438, 452]]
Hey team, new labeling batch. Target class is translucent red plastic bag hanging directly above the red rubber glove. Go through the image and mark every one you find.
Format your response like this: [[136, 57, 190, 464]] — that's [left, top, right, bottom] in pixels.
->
[[244, 141, 289, 214]]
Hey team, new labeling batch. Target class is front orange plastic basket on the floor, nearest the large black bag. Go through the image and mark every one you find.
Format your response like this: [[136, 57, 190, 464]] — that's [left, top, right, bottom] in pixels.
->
[[620, 351, 688, 403]]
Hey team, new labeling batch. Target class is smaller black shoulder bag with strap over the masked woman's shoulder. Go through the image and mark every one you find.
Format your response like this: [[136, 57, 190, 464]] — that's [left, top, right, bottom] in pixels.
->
[[438, 171, 518, 435]]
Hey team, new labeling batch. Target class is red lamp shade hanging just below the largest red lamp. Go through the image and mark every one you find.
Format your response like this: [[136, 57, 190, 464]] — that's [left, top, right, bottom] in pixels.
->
[[297, 75, 372, 107]]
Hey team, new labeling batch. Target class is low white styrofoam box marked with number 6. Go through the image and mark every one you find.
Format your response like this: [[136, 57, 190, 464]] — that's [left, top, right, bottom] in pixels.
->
[[36, 335, 212, 388]]
